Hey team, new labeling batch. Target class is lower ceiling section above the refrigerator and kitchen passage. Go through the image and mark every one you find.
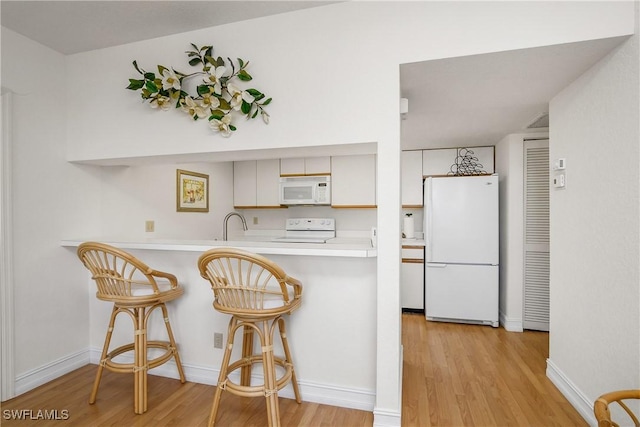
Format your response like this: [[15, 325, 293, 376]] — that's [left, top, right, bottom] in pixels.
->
[[400, 37, 625, 150]]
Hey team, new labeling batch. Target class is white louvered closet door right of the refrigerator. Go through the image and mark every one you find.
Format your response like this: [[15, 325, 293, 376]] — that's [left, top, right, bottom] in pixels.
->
[[523, 139, 549, 331]]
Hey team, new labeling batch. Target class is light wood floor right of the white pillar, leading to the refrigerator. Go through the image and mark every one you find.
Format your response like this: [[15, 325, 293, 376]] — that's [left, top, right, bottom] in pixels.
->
[[402, 314, 587, 427]]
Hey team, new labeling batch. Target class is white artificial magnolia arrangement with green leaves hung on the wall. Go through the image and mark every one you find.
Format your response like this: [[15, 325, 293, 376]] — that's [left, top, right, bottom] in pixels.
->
[[127, 43, 271, 137]]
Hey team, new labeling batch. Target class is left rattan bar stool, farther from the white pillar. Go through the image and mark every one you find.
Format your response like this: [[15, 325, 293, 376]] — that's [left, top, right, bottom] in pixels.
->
[[78, 242, 185, 414]]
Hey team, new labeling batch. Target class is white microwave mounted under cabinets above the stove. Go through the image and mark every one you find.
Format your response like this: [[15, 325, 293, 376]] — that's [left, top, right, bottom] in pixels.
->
[[280, 175, 331, 206]]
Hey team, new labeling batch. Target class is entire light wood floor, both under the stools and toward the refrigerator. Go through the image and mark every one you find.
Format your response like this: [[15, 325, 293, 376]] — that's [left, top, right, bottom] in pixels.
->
[[0, 314, 587, 427]]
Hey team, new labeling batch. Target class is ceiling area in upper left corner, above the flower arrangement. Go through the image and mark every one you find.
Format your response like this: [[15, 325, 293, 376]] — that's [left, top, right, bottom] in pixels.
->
[[0, 0, 336, 55]]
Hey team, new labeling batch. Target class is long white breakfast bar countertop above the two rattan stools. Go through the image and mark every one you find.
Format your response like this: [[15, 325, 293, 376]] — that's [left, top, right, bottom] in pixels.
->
[[60, 236, 378, 258]]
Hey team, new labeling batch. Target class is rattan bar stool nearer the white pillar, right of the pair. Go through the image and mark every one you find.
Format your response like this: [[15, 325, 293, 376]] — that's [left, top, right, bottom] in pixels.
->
[[198, 248, 302, 427]]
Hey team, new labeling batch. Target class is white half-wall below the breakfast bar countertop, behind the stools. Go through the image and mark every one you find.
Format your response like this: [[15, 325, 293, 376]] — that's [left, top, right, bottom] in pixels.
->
[[85, 250, 376, 411]]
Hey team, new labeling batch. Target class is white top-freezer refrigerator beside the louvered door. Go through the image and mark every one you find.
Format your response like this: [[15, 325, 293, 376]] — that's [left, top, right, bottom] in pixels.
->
[[424, 175, 499, 327]]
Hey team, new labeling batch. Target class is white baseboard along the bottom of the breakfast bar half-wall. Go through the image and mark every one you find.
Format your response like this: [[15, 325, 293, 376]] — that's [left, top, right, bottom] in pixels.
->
[[90, 347, 376, 412]]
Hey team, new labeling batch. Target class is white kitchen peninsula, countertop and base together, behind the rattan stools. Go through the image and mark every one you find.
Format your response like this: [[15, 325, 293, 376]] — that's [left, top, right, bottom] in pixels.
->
[[61, 236, 377, 411]]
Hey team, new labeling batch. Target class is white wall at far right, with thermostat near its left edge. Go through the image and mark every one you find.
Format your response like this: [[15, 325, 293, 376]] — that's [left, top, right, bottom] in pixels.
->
[[548, 11, 640, 417]]
